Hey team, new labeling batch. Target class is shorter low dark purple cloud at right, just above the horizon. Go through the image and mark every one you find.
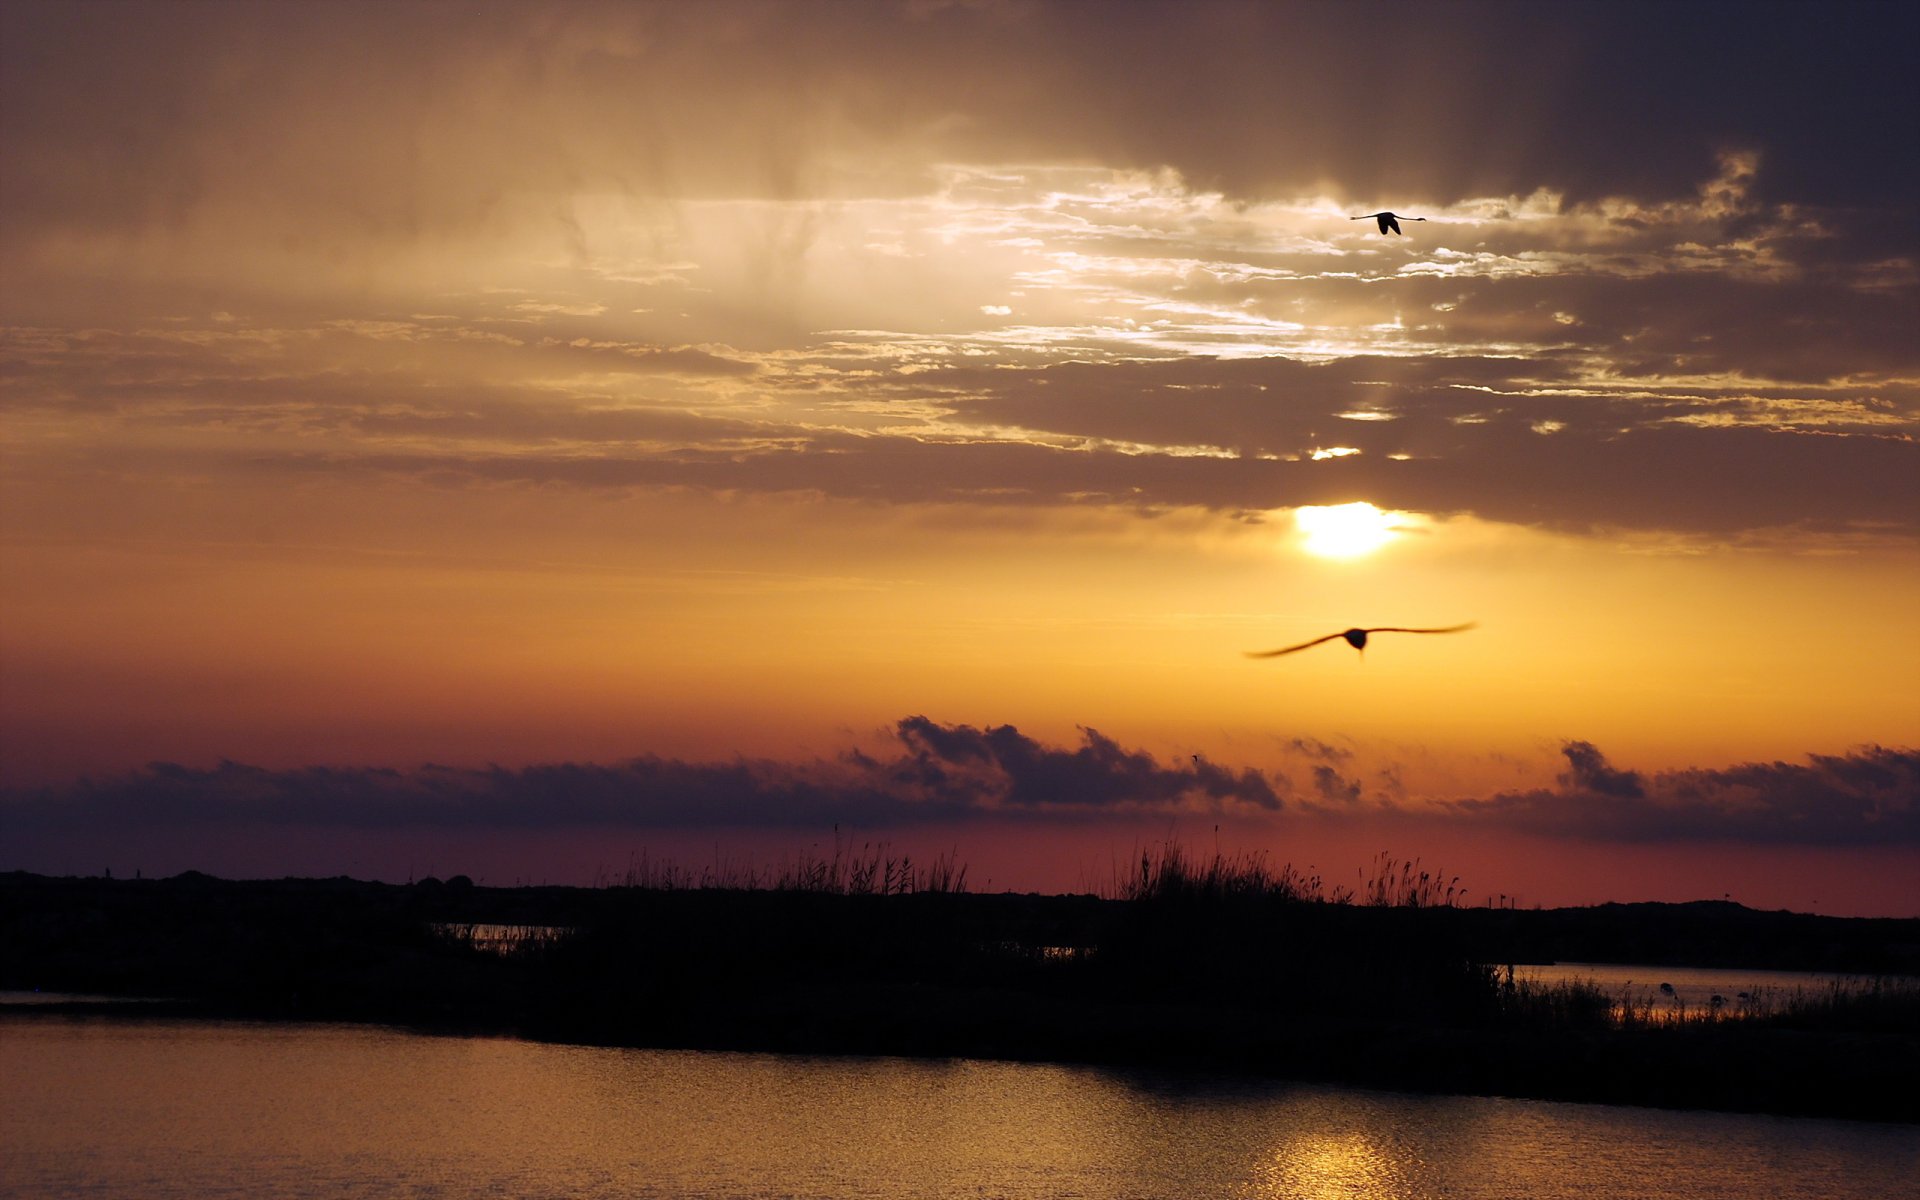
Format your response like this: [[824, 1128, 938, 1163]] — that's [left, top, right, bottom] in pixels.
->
[[1444, 741, 1920, 847]]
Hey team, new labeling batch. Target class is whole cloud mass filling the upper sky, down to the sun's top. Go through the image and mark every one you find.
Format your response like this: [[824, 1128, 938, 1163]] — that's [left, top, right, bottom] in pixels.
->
[[0, 0, 1920, 549]]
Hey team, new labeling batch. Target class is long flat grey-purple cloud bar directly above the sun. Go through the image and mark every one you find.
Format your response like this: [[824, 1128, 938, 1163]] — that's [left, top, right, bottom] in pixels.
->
[[253, 420, 1920, 534]]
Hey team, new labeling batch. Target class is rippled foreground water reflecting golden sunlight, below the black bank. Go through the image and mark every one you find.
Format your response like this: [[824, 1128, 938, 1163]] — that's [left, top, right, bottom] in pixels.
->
[[0, 1016, 1920, 1200]]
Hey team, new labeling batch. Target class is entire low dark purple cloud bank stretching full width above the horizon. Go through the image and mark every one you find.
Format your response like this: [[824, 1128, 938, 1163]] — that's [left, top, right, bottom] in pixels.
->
[[0, 716, 1920, 847]]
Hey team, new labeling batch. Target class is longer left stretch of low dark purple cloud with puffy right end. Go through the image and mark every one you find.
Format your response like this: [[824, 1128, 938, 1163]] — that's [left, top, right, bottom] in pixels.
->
[[0, 716, 1281, 833]]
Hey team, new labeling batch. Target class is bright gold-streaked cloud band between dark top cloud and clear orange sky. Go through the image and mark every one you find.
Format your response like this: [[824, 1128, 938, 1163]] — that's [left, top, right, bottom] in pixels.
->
[[0, 140, 1920, 536]]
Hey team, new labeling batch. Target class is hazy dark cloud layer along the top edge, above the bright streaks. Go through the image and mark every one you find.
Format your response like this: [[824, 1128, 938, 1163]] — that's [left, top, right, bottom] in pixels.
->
[[0, 0, 1920, 224]]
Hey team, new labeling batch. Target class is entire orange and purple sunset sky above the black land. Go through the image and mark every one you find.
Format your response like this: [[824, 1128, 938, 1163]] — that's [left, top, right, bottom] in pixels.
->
[[0, 0, 1920, 916]]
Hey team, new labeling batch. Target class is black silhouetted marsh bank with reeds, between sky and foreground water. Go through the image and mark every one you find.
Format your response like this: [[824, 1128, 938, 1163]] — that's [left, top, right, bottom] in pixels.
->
[[0, 835, 1920, 1119]]
